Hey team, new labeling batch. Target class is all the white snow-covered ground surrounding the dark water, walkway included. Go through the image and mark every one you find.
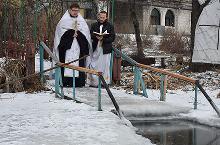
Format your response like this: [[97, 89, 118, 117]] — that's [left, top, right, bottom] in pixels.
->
[[0, 52, 220, 145]]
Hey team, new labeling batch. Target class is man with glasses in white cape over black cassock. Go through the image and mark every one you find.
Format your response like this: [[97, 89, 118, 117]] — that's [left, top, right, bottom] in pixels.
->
[[54, 3, 91, 87]]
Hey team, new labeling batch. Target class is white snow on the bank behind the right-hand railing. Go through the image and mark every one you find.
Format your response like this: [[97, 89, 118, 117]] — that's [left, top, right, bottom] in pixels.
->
[[148, 88, 220, 127]]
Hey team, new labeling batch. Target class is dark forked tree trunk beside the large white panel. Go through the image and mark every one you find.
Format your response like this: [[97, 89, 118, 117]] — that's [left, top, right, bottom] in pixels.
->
[[190, 0, 211, 70]]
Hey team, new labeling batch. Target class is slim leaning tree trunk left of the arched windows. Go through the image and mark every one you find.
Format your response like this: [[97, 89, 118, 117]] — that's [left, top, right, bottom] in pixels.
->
[[128, 0, 144, 56]]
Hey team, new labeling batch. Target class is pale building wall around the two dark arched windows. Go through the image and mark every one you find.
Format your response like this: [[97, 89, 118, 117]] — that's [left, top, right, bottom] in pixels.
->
[[115, 0, 191, 35]]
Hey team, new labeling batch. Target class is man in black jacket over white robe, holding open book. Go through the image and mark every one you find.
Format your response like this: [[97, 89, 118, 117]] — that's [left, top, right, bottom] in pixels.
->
[[87, 11, 115, 87]]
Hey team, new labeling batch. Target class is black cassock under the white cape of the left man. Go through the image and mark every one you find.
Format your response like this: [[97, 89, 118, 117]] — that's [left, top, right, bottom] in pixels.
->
[[58, 29, 89, 87]]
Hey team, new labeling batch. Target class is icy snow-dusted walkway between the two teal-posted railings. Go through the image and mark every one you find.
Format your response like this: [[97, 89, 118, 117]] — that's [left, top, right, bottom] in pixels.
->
[[61, 87, 191, 117]]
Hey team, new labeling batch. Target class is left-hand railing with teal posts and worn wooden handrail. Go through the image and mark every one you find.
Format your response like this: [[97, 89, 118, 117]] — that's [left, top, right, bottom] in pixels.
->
[[39, 42, 123, 118]]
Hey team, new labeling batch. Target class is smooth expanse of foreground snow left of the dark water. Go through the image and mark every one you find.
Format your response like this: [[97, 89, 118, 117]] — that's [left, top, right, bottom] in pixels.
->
[[0, 92, 151, 145]]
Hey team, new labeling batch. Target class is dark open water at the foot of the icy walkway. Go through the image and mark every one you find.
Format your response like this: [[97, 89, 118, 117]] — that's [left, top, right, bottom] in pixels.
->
[[132, 121, 220, 145]]
